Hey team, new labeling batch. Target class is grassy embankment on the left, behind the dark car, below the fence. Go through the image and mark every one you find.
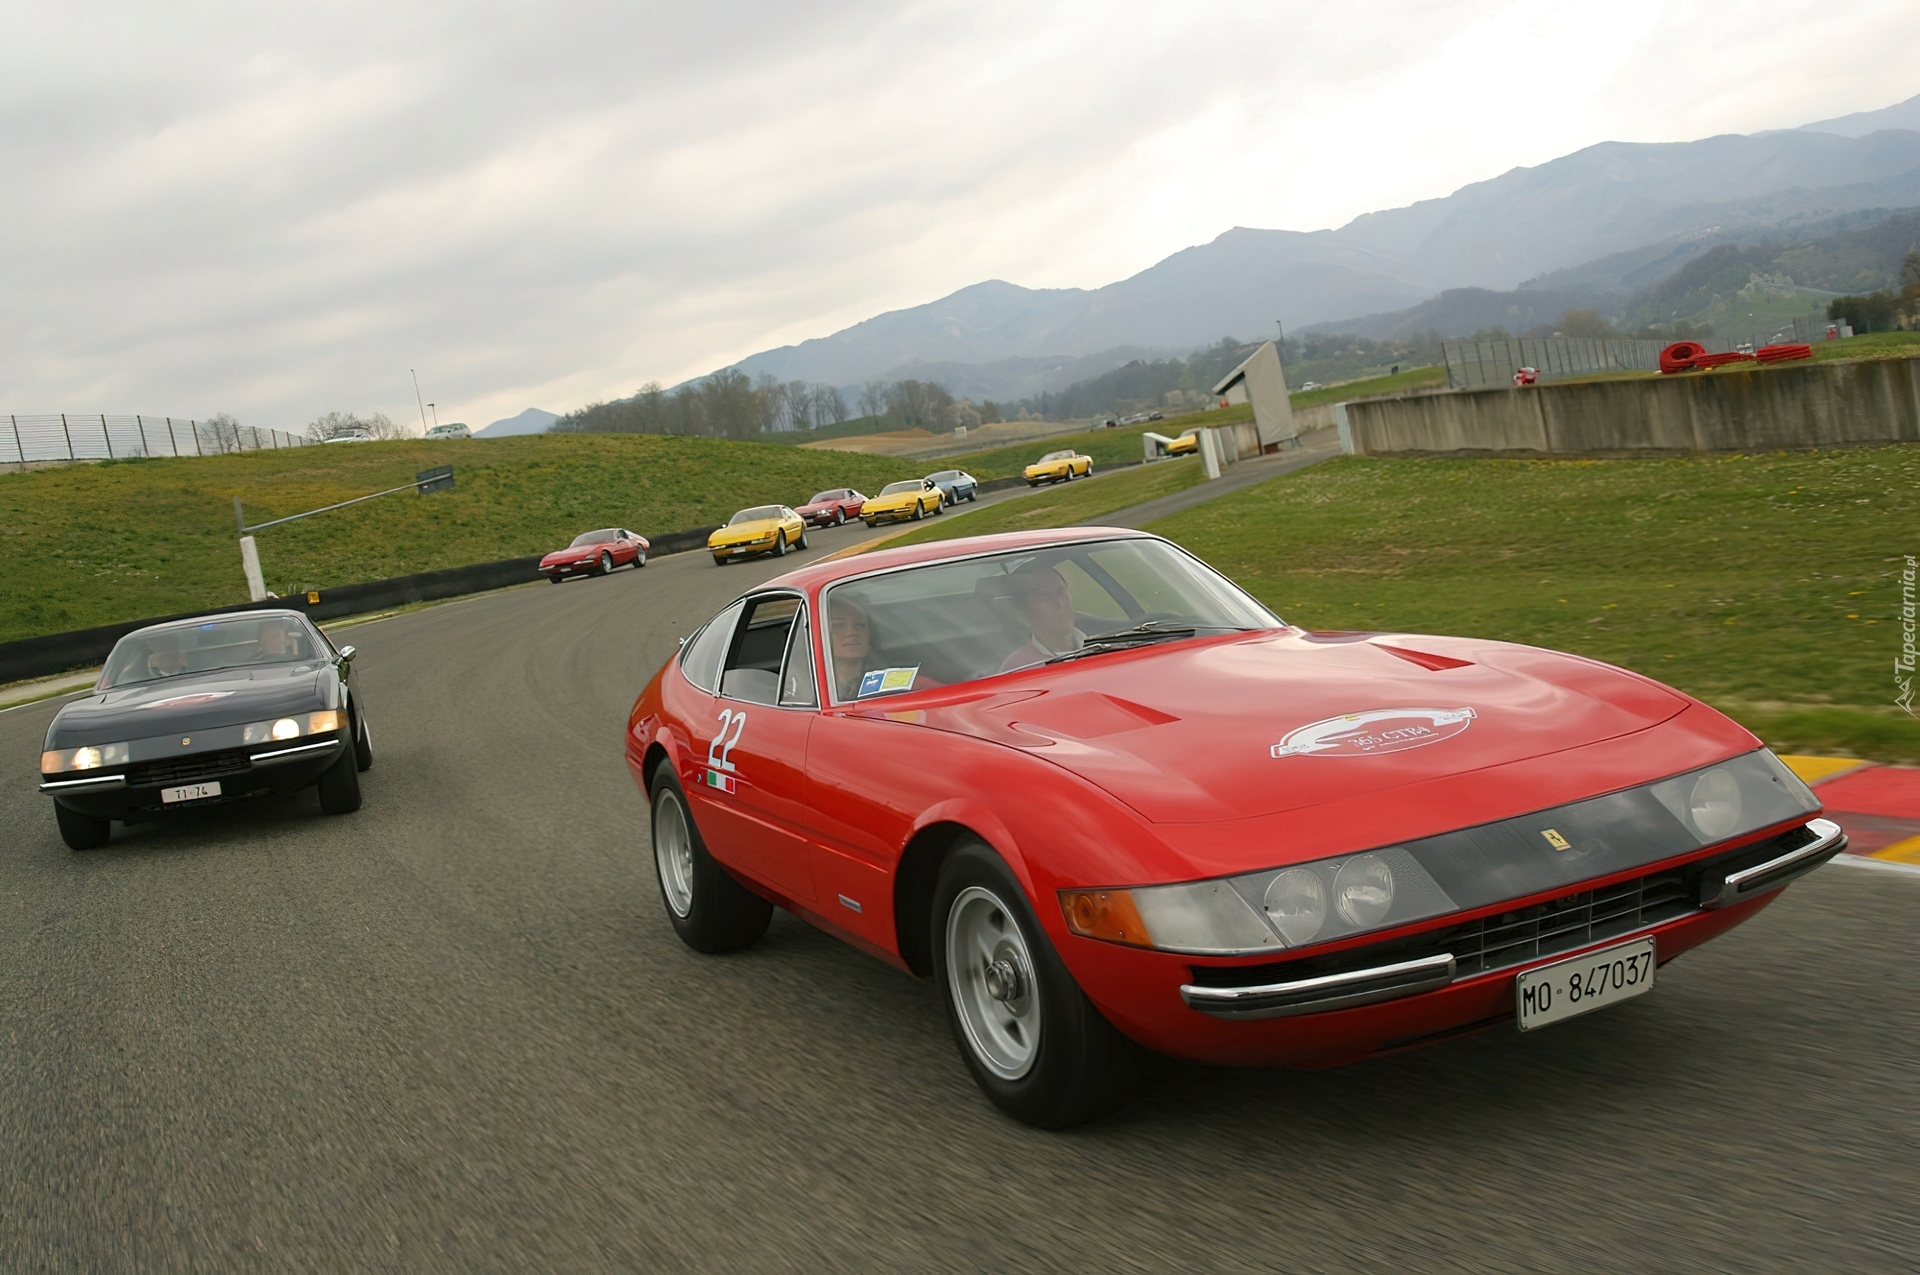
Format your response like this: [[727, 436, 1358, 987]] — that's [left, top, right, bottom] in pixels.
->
[[0, 434, 924, 641]]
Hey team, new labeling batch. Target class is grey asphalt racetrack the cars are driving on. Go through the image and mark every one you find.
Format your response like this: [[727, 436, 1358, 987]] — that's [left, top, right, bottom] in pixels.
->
[[0, 528, 1920, 1271]]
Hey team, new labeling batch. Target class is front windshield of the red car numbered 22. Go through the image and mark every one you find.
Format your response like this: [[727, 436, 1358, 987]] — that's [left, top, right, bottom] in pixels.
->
[[826, 538, 1283, 703]]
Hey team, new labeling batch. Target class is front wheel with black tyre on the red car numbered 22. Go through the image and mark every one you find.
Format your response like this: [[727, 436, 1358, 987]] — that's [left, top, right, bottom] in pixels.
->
[[927, 839, 1140, 1129]]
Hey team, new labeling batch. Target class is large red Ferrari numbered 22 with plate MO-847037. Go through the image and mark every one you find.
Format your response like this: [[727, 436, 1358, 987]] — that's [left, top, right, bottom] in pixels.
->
[[626, 528, 1845, 1127]]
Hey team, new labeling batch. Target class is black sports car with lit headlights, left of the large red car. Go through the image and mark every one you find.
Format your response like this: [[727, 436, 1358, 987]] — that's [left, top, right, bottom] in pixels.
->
[[40, 611, 372, 851]]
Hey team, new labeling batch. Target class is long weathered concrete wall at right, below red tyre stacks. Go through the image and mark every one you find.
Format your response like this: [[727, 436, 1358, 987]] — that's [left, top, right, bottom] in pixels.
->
[[1338, 359, 1920, 455]]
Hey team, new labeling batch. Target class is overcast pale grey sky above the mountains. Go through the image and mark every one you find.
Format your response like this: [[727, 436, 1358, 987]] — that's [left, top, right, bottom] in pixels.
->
[[0, 0, 1920, 428]]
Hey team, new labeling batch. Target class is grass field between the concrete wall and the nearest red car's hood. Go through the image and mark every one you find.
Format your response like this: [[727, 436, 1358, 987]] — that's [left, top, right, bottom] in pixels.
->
[[1148, 445, 1920, 760]]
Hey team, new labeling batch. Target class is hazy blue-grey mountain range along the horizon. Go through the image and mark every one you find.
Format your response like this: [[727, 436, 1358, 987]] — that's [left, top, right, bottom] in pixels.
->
[[718, 96, 1920, 401]]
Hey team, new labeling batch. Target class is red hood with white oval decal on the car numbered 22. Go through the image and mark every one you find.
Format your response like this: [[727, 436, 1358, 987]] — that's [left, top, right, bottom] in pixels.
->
[[879, 630, 1690, 824]]
